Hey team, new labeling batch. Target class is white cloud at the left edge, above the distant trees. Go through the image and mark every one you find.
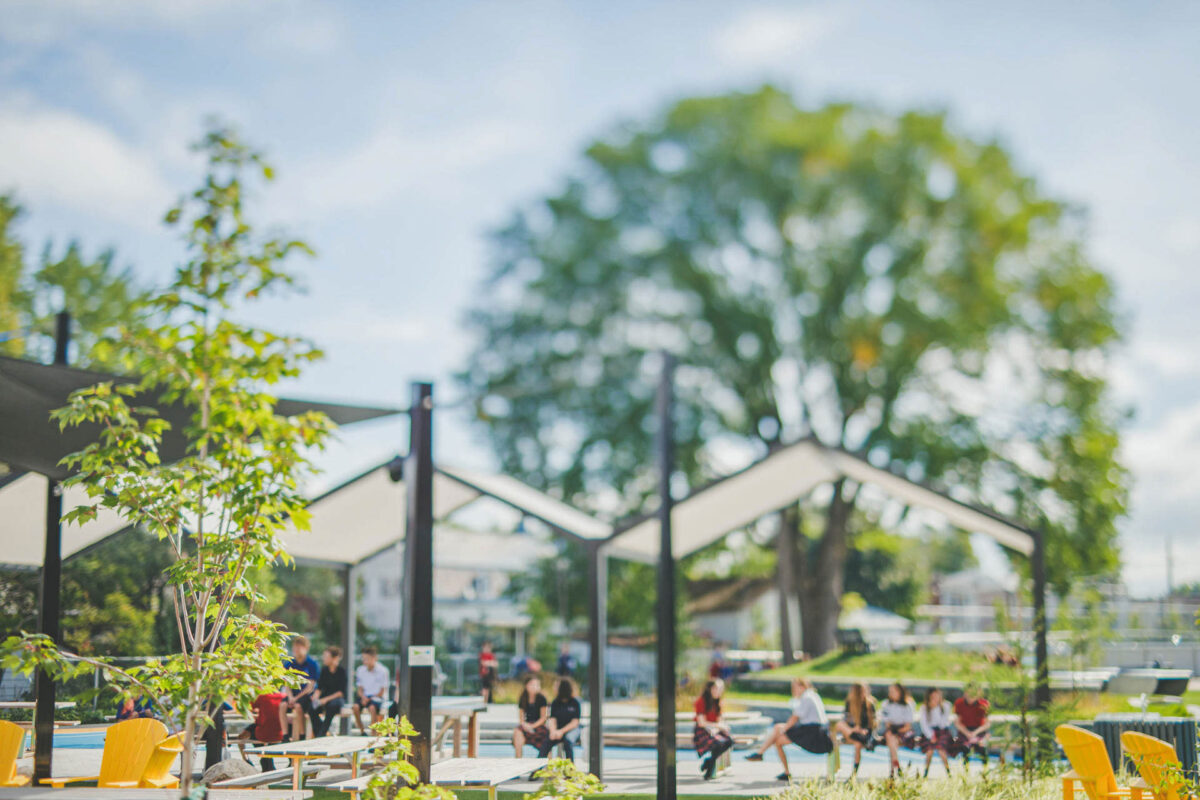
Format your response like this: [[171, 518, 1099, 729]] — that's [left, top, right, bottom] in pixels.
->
[[0, 107, 173, 227]]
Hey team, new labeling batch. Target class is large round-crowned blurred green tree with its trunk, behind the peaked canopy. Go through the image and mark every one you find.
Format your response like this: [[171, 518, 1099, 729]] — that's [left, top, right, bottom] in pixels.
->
[[462, 88, 1126, 654]]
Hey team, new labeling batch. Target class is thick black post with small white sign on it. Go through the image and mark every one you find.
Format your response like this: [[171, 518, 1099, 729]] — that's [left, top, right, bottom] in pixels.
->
[[401, 383, 433, 783]]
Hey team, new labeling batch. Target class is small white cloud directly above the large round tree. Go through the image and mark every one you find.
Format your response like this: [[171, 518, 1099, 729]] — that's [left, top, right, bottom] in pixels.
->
[[713, 6, 840, 66]]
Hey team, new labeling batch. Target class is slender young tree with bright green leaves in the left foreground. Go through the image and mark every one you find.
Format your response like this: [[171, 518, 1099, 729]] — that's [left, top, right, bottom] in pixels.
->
[[5, 127, 330, 794]]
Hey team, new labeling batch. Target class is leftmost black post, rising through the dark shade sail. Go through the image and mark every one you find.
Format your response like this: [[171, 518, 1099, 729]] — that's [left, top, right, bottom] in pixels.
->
[[34, 311, 71, 784]]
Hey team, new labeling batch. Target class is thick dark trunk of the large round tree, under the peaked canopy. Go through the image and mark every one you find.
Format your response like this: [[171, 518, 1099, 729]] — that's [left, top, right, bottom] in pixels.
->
[[800, 479, 853, 657]]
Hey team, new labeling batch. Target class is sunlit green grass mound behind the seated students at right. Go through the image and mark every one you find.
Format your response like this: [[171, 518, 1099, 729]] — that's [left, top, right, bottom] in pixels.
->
[[751, 650, 1016, 684]]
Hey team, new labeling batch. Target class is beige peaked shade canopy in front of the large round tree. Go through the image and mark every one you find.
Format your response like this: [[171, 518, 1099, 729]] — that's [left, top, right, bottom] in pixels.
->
[[610, 439, 1033, 561]]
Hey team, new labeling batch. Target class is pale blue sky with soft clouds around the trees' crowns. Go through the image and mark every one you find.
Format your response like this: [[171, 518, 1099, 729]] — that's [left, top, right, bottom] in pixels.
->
[[0, 0, 1200, 595]]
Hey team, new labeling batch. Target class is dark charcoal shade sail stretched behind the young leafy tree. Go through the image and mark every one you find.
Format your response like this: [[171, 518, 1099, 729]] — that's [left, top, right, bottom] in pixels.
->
[[0, 356, 406, 481]]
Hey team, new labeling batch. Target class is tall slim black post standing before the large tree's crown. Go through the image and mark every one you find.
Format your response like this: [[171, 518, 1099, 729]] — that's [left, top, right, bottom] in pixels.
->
[[656, 351, 676, 800]]
